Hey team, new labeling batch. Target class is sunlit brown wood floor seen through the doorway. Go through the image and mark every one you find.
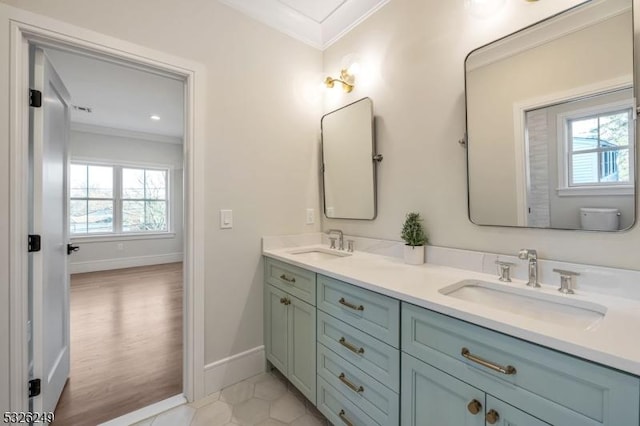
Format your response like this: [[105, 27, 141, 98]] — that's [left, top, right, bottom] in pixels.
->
[[53, 263, 183, 426]]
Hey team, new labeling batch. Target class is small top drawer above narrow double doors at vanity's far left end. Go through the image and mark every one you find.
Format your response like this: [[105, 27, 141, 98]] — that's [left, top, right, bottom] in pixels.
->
[[265, 257, 316, 306]]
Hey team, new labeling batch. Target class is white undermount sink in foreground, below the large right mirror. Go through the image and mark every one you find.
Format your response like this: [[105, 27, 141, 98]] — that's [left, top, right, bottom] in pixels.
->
[[439, 280, 607, 330]]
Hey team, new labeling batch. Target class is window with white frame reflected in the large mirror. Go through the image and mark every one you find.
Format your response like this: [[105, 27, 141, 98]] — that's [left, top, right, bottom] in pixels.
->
[[558, 97, 635, 195]]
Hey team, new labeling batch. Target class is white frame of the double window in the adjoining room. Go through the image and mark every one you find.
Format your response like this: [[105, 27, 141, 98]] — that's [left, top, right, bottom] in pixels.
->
[[68, 158, 175, 242]]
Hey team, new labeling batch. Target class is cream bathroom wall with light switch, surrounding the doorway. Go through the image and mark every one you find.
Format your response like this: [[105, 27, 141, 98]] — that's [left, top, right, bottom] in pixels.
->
[[0, 0, 323, 411]]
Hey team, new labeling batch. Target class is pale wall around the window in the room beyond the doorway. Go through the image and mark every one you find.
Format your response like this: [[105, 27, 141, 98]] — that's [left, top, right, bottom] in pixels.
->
[[69, 131, 183, 273]]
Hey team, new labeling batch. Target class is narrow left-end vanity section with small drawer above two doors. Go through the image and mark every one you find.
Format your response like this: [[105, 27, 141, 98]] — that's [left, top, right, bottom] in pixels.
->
[[264, 258, 316, 404]]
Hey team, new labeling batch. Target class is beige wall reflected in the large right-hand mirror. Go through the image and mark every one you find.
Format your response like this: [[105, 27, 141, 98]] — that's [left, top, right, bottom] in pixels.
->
[[467, 11, 633, 227]]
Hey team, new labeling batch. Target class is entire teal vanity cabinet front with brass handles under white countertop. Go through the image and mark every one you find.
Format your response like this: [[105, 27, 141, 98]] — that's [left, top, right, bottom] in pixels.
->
[[265, 258, 640, 426]]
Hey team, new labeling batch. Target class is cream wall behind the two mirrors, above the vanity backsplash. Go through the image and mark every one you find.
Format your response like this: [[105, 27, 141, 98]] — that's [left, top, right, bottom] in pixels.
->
[[323, 0, 640, 269]]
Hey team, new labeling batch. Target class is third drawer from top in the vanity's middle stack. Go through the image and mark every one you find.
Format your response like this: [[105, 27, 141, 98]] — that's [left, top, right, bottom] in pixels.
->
[[317, 344, 400, 426]]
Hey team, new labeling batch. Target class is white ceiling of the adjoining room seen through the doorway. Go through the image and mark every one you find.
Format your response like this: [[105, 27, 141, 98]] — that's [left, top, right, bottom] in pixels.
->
[[46, 49, 184, 143]]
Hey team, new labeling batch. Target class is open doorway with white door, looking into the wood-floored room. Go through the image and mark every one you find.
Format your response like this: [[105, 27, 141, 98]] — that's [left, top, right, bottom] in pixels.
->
[[30, 46, 184, 426]]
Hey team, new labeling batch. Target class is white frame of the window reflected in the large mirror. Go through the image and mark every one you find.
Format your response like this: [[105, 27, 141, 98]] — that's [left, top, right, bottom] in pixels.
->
[[556, 98, 636, 197]]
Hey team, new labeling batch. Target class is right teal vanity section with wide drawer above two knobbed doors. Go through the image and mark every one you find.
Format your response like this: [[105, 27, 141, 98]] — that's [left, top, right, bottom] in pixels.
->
[[401, 303, 640, 426]]
